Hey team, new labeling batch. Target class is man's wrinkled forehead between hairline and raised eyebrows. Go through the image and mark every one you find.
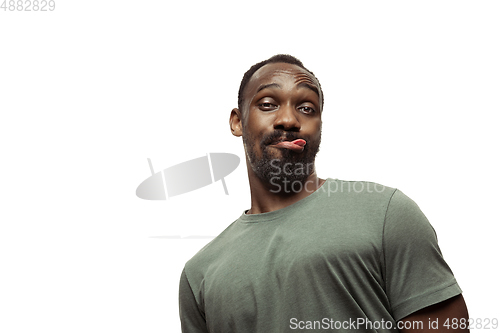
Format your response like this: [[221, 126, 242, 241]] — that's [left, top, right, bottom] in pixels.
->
[[246, 62, 319, 97]]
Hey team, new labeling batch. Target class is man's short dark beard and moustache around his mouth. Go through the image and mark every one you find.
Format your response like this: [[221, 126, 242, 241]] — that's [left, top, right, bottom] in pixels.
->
[[243, 130, 321, 193]]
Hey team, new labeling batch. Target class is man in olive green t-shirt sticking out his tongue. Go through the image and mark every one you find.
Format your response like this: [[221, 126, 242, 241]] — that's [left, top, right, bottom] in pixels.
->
[[179, 55, 468, 333]]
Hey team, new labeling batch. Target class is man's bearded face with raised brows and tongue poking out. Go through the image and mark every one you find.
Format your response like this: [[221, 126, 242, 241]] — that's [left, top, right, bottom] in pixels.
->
[[240, 63, 322, 188]]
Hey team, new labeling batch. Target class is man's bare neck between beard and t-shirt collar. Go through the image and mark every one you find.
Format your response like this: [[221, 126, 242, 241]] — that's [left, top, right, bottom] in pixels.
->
[[247, 162, 325, 214]]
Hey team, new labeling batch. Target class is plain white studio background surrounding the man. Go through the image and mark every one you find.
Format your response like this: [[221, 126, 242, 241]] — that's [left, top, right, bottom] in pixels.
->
[[0, 0, 500, 333]]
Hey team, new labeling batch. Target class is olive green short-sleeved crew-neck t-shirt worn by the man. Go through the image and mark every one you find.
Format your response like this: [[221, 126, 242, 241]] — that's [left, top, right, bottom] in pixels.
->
[[179, 179, 462, 333]]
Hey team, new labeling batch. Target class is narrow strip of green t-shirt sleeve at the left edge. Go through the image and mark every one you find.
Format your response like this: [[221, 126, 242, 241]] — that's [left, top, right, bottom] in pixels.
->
[[179, 270, 208, 333]]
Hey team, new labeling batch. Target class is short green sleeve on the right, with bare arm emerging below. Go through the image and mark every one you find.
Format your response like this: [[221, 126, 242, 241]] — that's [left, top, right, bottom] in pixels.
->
[[383, 190, 462, 320]]
